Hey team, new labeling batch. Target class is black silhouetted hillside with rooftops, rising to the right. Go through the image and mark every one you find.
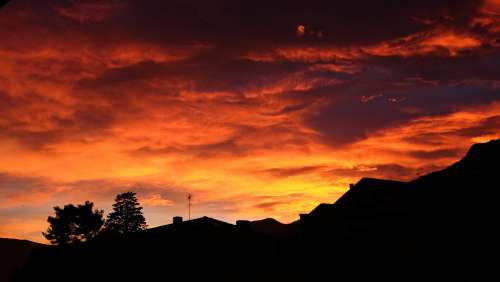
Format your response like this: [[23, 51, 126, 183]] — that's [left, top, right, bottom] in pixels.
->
[[6, 140, 500, 282]]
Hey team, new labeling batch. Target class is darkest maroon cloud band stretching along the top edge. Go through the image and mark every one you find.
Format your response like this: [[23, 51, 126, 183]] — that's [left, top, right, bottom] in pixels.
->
[[0, 0, 482, 53]]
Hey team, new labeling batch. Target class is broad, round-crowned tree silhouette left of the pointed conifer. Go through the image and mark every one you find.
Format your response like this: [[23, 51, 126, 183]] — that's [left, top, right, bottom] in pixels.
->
[[42, 201, 104, 245]]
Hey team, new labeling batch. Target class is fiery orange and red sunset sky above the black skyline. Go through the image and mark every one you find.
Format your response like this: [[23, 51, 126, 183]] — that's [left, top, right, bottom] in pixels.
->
[[0, 0, 500, 242]]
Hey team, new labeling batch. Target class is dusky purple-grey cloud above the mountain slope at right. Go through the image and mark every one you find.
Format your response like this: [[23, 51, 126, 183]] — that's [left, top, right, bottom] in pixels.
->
[[305, 69, 500, 146]]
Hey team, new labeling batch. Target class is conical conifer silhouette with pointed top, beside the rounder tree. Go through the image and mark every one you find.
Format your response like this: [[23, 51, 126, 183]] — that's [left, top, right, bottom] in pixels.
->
[[105, 192, 147, 234]]
